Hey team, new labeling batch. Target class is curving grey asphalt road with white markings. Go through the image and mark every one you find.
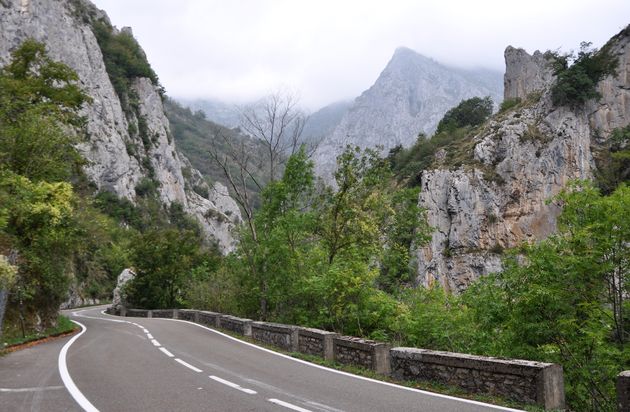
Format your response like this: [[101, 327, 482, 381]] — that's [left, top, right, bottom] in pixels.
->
[[0, 307, 524, 412]]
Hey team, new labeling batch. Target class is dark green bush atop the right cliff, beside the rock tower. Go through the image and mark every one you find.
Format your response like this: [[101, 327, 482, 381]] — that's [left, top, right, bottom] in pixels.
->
[[551, 42, 619, 109]]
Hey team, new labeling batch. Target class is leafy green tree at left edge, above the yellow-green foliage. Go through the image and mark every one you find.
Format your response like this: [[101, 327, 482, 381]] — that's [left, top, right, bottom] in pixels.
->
[[0, 40, 89, 181]]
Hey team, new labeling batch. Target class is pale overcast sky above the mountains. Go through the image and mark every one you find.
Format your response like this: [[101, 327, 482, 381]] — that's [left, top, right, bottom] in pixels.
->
[[93, 0, 630, 110]]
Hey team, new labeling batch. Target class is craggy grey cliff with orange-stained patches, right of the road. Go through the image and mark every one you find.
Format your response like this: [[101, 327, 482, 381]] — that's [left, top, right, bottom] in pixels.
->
[[415, 26, 630, 291]]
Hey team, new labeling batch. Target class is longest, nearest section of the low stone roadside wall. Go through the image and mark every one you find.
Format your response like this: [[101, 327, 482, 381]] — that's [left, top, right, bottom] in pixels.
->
[[391, 348, 564, 409]]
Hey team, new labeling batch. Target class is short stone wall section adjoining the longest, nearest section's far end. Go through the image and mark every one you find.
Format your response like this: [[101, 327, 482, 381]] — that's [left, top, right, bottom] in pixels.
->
[[333, 336, 391, 375]]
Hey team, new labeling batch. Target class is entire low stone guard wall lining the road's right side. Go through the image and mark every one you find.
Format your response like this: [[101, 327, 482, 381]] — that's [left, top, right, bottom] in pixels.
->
[[113, 308, 572, 412]]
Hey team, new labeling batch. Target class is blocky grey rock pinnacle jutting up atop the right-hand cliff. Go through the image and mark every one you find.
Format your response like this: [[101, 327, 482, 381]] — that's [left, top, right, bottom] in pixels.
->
[[503, 46, 553, 100]]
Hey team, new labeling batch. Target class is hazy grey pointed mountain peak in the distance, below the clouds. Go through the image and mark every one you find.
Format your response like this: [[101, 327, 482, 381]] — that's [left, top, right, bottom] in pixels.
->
[[315, 47, 503, 175]]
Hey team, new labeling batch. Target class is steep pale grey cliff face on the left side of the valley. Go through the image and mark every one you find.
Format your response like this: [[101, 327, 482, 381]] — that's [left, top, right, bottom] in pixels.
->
[[0, 0, 240, 251]]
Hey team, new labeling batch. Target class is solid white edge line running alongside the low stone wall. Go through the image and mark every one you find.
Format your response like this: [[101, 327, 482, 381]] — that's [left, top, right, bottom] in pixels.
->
[[158, 315, 523, 412]]
